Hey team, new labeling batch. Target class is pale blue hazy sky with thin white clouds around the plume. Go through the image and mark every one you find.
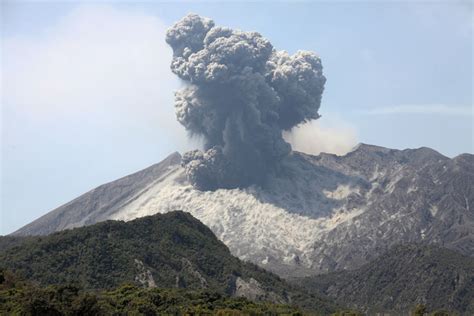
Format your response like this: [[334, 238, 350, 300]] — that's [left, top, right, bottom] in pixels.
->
[[0, 1, 474, 234]]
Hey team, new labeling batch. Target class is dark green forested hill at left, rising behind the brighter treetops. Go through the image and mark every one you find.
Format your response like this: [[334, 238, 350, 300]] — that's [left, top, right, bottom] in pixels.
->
[[0, 211, 333, 312]]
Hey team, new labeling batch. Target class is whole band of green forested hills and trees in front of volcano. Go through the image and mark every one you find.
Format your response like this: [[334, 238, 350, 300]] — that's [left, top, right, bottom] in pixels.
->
[[0, 212, 474, 316]]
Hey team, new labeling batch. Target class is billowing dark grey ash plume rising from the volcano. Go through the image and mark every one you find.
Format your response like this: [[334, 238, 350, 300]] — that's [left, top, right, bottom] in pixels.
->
[[166, 14, 326, 190]]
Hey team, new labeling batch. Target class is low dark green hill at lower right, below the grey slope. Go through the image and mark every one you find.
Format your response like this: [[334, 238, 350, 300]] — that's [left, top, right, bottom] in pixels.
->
[[294, 244, 474, 315]]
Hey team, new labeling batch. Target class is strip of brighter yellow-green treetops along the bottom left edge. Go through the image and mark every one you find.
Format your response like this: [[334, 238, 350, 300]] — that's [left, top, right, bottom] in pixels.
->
[[0, 271, 302, 316]]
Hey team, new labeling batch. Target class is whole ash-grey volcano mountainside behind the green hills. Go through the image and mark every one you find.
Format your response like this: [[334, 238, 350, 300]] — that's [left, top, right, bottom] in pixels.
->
[[14, 144, 474, 276]]
